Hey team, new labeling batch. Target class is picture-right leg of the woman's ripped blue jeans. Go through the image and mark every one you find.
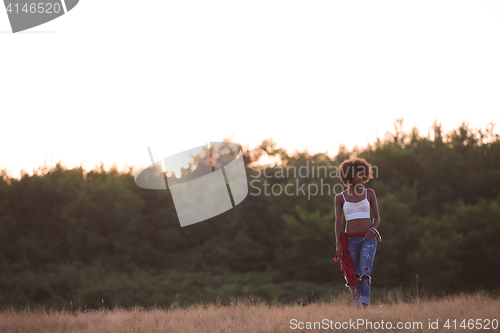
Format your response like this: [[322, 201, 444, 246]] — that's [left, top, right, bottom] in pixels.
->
[[358, 237, 377, 304]]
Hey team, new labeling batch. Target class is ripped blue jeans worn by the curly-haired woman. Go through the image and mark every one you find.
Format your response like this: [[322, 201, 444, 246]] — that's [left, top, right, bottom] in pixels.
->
[[346, 236, 377, 307]]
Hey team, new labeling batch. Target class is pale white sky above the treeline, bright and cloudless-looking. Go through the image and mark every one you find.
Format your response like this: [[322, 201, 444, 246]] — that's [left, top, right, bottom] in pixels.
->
[[0, 0, 500, 176]]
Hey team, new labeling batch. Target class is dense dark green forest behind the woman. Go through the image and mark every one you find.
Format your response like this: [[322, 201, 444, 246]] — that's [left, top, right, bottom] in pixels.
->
[[0, 120, 500, 309]]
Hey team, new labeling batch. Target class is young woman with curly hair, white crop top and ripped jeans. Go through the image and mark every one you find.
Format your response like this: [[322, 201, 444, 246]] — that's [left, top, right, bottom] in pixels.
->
[[335, 158, 381, 307]]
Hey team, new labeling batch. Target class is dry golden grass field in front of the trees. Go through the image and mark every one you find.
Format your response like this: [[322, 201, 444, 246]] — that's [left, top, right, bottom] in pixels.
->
[[0, 292, 500, 333]]
